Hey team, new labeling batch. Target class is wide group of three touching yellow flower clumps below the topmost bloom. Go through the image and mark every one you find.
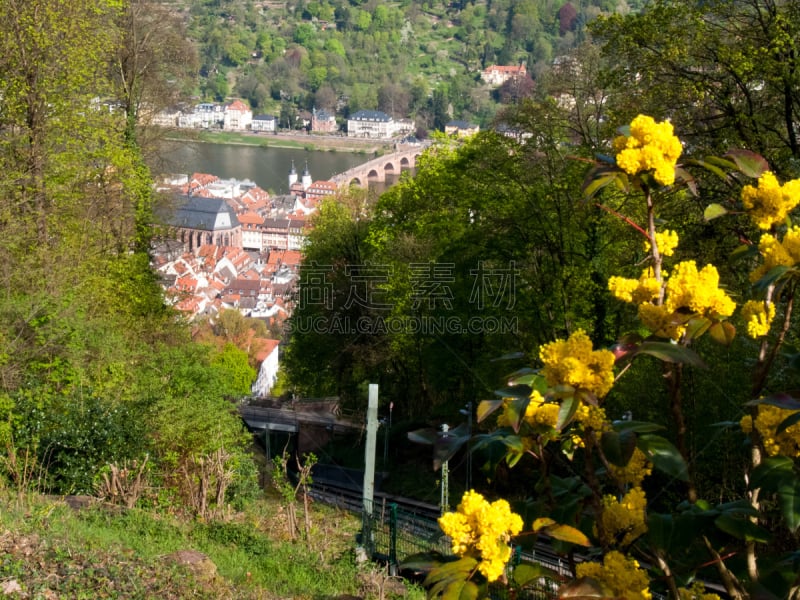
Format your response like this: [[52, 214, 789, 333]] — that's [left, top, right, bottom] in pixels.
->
[[608, 260, 736, 339]]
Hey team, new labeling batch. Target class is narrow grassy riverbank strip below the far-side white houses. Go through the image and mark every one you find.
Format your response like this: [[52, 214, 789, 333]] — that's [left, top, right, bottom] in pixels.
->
[[164, 129, 392, 155]]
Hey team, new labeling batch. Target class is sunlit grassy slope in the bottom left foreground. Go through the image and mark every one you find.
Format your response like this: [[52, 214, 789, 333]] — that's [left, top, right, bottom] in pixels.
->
[[0, 490, 424, 600]]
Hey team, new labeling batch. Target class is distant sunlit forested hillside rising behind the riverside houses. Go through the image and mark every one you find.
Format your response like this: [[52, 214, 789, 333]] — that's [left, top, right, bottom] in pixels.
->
[[176, 0, 638, 130]]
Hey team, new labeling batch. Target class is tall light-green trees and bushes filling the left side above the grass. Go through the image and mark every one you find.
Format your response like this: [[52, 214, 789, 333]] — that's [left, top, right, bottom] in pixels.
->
[[0, 0, 255, 515]]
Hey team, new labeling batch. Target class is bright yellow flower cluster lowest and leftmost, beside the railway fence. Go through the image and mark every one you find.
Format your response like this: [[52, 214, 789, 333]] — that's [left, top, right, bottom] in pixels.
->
[[439, 490, 522, 581]]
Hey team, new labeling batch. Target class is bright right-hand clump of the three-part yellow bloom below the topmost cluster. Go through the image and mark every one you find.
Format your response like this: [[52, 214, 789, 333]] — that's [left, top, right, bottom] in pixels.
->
[[664, 260, 736, 319]]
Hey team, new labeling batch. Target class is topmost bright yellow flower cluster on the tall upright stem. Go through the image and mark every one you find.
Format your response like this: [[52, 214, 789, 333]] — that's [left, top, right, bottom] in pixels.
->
[[614, 115, 683, 185]]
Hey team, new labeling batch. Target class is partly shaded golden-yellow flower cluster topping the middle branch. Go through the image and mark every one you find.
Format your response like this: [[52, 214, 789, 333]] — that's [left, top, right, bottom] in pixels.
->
[[539, 330, 614, 398]]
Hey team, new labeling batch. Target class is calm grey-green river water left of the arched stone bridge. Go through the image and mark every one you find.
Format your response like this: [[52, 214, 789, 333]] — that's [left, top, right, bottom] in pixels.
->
[[159, 142, 382, 194]]
